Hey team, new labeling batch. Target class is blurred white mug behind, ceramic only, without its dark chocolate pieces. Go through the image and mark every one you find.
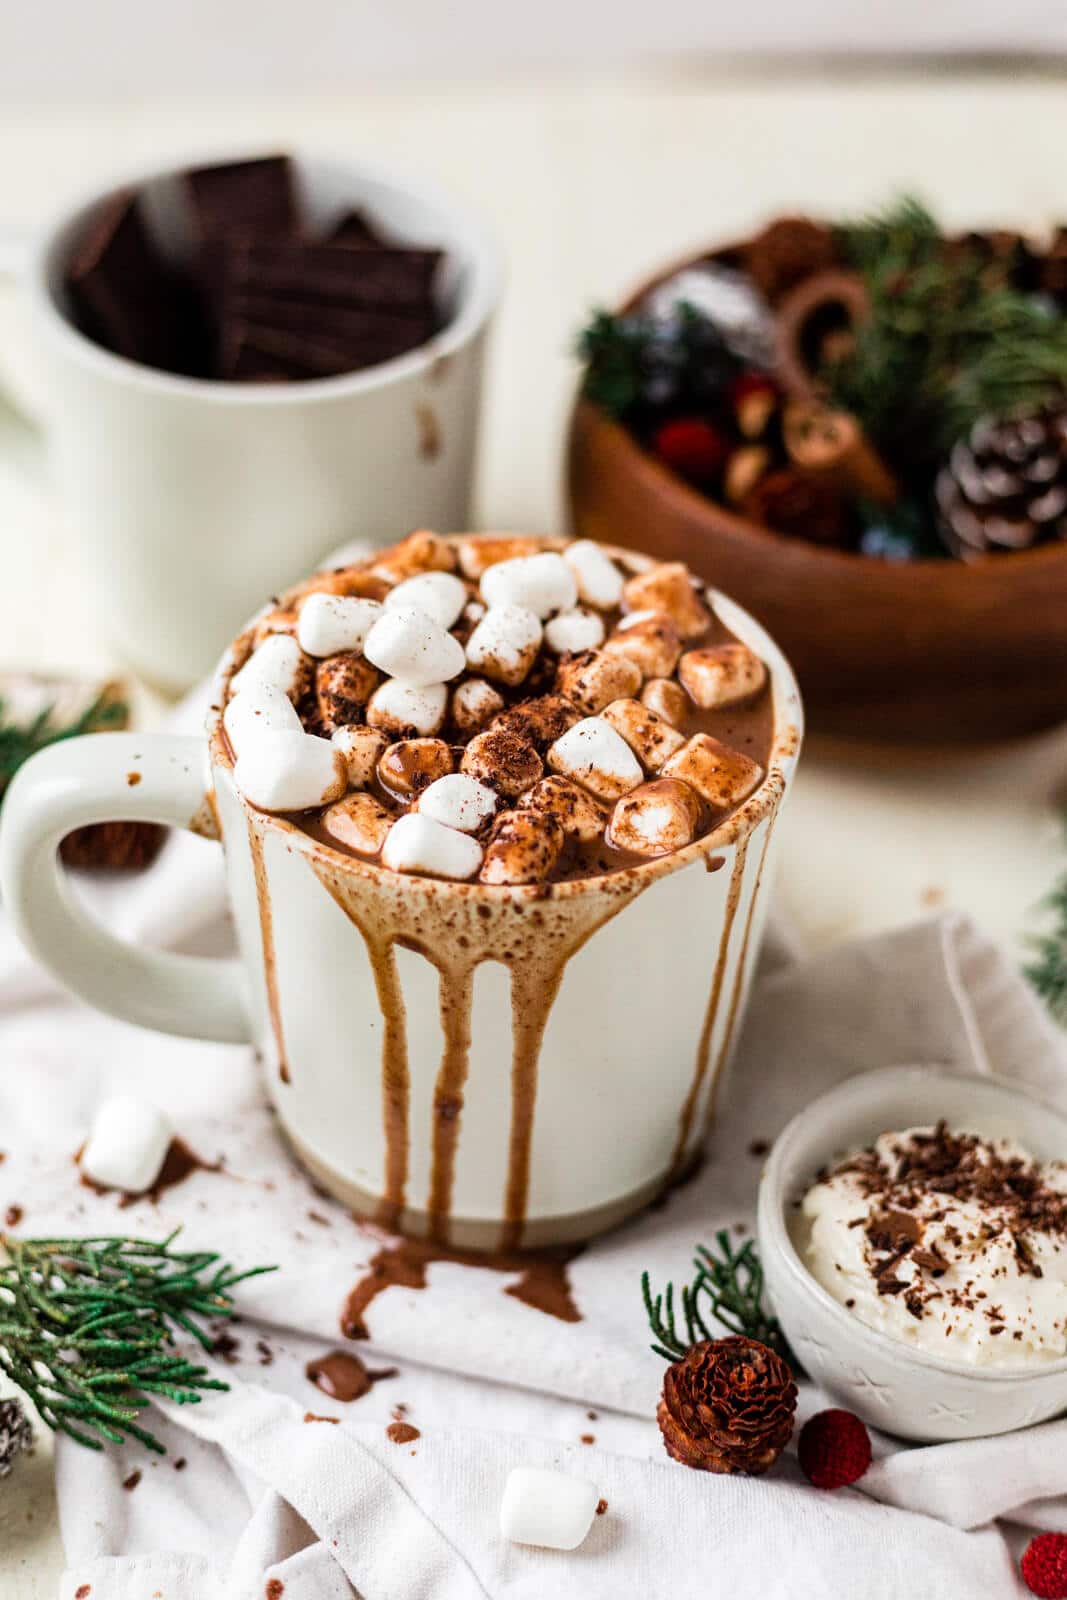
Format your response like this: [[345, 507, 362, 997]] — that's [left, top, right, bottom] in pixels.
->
[[0, 157, 501, 688]]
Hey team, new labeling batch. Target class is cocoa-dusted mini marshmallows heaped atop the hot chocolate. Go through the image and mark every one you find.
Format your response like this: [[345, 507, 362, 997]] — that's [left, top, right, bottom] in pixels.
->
[[224, 531, 766, 885]]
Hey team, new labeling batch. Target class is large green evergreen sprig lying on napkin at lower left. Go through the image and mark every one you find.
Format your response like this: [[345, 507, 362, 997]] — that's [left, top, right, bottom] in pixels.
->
[[0, 1230, 274, 1454]]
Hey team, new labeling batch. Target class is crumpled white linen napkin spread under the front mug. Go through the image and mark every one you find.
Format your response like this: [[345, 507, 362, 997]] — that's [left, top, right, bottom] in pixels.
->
[[0, 704, 1067, 1600]]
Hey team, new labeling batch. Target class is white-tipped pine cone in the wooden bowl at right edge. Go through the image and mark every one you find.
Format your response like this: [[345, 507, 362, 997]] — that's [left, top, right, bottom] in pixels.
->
[[934, 405, 1067, 560]]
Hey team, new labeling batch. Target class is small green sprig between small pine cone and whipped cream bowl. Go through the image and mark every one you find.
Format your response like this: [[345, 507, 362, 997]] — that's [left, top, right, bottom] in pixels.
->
[[641, 1229, 797, 1368]]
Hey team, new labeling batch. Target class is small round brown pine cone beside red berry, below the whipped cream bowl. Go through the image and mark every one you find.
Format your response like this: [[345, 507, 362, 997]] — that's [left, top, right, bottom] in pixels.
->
[[656, 1336, 797, 1475]]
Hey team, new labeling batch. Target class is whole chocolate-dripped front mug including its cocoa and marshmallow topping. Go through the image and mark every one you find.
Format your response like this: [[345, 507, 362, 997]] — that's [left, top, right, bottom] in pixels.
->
[[0, 531, 801, 1250]]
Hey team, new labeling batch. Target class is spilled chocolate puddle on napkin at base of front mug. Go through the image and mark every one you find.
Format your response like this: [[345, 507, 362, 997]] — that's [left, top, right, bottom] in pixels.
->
[[341, 1238, 582, 1339]]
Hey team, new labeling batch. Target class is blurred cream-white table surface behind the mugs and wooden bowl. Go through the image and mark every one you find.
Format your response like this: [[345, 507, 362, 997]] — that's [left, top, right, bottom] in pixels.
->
[[0, 67, 1067, 1600]]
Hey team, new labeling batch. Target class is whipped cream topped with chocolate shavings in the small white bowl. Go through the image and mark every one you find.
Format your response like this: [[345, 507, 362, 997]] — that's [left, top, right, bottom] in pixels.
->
[[801, 1123, 1067, 1366]]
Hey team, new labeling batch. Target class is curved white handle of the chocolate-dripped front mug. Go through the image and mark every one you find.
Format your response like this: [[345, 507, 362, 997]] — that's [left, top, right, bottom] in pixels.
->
[[0, 733, 251, 1043]]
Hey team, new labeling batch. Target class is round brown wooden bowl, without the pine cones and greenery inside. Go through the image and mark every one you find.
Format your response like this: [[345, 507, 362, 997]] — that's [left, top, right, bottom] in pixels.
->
[[568, 258, 1067, 744]]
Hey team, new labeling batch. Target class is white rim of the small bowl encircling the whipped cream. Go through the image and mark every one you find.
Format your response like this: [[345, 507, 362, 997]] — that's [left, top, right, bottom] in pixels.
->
[[758, 1062, 1067, 1384]]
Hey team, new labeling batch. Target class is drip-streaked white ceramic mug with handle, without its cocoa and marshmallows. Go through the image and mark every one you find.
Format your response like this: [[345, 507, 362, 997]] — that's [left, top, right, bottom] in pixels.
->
[[0, 552, 801, 1250]]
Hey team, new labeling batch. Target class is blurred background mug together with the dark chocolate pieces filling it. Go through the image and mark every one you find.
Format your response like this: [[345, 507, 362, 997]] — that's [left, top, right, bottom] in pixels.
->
[[0, 157, 499, 688]]
